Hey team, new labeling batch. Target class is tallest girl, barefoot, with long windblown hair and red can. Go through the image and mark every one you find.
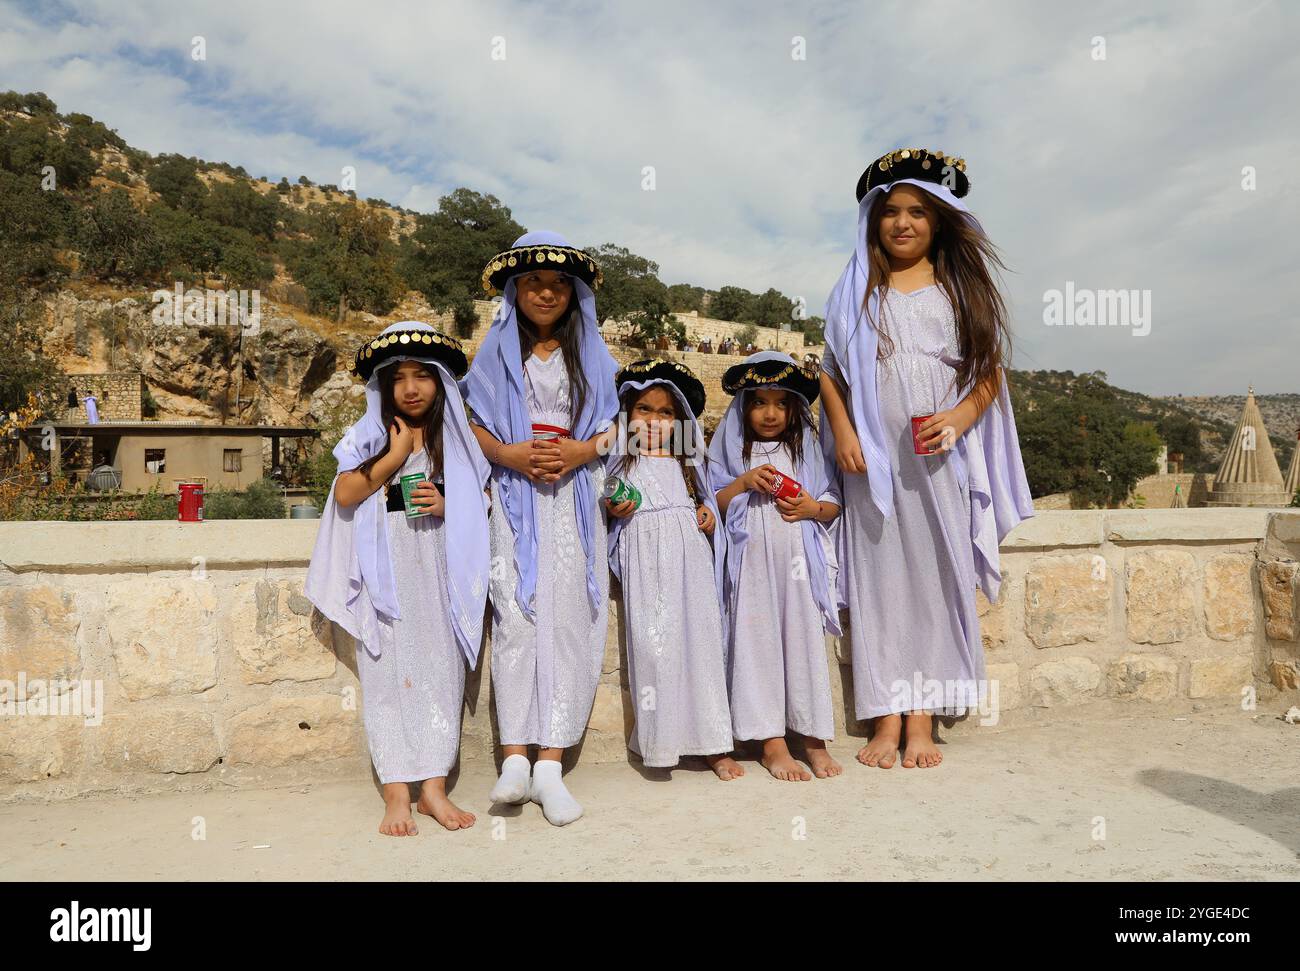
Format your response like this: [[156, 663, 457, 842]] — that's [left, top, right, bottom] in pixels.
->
[[822, 148, 1034, 768]]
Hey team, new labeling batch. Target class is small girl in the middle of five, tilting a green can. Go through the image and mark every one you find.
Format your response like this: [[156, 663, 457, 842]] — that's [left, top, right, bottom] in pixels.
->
[[606, 360, 745, 781]]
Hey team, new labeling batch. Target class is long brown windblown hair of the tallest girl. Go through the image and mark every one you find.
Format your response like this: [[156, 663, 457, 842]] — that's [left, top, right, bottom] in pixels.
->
[[867, 190, 1011, 394]]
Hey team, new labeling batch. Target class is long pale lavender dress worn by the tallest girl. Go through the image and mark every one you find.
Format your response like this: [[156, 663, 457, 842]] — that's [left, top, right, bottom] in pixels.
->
[[827, 286, 985, 719]]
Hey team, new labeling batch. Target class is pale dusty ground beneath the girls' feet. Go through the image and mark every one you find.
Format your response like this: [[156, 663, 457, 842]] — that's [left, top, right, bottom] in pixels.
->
[[0, 708, 1300, 880]]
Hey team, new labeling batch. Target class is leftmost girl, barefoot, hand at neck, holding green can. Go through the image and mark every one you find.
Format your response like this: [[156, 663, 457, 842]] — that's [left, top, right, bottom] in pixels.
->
[[304, 321, 489, 836]]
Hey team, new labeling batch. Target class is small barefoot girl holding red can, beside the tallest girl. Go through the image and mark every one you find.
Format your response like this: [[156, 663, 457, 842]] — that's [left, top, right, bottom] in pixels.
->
[[709, 351, 841, 781]]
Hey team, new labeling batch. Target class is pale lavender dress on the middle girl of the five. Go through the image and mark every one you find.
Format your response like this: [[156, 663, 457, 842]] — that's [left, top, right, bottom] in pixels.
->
[[618, 455, 732, 767]]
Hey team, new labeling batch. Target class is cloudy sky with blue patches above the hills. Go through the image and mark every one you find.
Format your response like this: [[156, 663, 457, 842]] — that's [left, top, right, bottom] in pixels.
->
[[0, 0, 1300, 394]]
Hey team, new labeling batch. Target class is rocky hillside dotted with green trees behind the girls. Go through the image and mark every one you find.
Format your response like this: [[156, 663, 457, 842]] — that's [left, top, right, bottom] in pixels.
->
[[0, 92, 1300, 493]]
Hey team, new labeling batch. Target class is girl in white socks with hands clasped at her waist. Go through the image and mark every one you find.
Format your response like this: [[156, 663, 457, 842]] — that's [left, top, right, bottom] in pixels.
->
[[465, 233, 619, 825]]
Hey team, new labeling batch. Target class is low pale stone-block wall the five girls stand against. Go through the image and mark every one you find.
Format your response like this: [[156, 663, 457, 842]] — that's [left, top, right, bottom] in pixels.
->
[[0, 504, 1300, 799]]
